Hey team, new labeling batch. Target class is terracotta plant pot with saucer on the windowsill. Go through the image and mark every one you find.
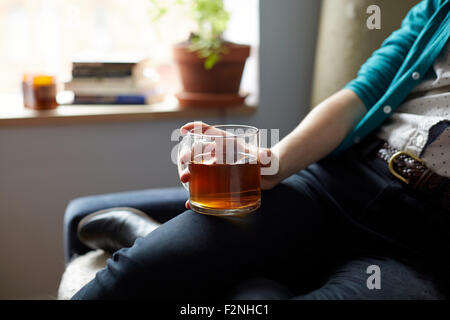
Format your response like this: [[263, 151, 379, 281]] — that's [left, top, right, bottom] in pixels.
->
[[173, 42, 250, 106]]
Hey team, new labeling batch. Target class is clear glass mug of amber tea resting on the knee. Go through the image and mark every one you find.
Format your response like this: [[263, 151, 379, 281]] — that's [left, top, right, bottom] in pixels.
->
[[178, 125, 261, 216]]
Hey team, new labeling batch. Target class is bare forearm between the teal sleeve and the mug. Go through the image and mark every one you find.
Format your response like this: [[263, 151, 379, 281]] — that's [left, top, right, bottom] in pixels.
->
[[272, 89, 366, 181]]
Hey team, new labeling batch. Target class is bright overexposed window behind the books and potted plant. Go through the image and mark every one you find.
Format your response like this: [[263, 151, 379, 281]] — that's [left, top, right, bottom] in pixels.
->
[[0, 0, 259, 101]]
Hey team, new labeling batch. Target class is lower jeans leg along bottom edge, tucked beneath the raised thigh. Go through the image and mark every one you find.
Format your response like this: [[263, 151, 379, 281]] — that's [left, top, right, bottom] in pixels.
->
[[225, 257, 445, 300]]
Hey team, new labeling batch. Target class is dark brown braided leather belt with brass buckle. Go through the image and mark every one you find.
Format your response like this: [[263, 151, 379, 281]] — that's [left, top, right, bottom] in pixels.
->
[[376, 142, 450, 212]]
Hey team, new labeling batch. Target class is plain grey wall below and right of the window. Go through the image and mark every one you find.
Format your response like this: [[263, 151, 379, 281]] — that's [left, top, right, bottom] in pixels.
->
[[0, 0, 320, 299]]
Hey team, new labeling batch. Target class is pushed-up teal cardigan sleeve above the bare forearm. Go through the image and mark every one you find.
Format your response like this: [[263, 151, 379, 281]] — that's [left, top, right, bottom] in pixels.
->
[[344, 0, 439, 110]]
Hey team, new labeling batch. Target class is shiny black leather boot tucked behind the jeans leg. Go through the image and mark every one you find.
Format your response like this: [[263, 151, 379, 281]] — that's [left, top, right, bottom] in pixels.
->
[[78, 207, 160, 253]]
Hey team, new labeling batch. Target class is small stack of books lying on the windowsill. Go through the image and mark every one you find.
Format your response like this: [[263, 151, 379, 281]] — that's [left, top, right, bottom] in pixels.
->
[[64, 54, 163, 104]]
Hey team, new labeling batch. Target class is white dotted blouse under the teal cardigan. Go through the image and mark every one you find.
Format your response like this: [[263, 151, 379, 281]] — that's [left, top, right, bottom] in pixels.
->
[[377, 41, 450, 177]]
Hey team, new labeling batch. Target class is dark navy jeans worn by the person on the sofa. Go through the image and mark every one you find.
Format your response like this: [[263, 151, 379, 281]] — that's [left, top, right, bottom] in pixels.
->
[[68, 140, 450, 299]]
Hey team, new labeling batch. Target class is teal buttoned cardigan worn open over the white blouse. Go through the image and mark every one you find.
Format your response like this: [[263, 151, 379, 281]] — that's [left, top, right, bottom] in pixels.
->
[[332, 0, 450, 155]]
